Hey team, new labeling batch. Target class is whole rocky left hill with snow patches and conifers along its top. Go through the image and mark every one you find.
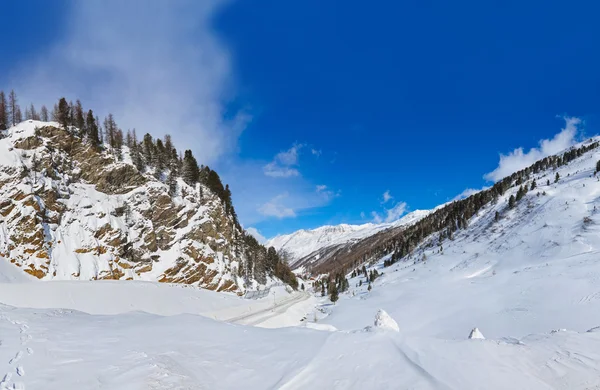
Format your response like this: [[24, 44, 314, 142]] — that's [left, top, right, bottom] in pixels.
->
[[0, 91, 297, 292]]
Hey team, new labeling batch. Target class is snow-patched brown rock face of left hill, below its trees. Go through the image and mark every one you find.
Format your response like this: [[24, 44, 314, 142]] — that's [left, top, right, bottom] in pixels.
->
[[0, 121, 264, 292]]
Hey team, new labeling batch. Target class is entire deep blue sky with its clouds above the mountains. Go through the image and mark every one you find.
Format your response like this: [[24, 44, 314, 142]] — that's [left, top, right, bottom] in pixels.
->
[[0, 0, 600, 237]]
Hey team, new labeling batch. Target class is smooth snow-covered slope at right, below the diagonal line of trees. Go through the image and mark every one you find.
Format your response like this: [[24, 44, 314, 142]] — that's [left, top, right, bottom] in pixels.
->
[[323, 138, 600, 339]]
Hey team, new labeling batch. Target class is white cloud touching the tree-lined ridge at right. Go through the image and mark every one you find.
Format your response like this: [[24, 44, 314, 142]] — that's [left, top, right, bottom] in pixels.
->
[[483, 117, 581, 182]]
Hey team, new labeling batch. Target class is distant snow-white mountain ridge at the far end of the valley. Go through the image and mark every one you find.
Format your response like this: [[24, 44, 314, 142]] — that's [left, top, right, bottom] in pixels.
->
[[265, 210, 429, 259]]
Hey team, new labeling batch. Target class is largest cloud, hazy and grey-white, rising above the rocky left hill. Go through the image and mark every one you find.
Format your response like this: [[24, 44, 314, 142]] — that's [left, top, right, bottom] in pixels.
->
[[6, 0, 241, 164]]
